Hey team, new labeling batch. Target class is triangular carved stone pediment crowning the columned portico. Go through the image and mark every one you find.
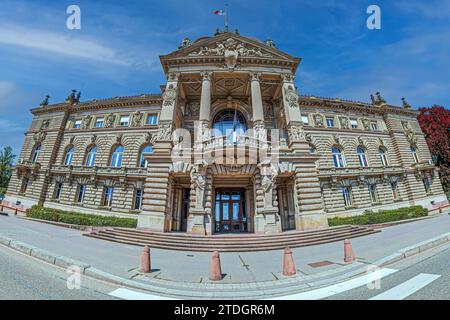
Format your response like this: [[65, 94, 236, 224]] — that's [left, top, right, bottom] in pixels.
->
[[161, 32, 300, 63]]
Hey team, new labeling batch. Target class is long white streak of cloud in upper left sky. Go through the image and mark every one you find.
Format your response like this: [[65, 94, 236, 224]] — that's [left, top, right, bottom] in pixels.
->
[[0, 25, 132, 65]]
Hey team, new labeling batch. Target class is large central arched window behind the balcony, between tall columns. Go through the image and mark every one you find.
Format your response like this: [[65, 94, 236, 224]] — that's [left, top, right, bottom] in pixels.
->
[[213, 109, 247, 142]]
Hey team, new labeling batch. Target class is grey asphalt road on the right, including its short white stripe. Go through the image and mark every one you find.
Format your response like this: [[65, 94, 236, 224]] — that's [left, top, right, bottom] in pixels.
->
[[329, 245, 450, 300]]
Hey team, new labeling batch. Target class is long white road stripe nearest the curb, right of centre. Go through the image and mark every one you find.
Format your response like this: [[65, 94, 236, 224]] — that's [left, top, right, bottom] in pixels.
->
[[273, 268, 398, 300]]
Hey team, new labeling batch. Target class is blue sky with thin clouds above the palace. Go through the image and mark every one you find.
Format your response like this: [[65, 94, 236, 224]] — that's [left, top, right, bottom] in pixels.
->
[[0, 0, 450, 153]]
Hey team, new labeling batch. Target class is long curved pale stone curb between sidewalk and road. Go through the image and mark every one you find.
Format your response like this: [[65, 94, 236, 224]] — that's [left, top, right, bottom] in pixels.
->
[[0, 232, 450, 299]]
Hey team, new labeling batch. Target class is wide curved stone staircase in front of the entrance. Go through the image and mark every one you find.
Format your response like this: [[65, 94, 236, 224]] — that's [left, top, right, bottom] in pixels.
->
[[85, 226, 380, 252]]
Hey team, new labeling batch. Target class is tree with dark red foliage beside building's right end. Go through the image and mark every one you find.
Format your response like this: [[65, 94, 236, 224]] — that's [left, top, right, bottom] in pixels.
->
[[418, 105, 450, 191]]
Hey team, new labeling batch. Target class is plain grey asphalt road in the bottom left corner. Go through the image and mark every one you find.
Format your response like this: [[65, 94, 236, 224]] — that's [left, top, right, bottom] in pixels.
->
[[0, 245, 117, 300]]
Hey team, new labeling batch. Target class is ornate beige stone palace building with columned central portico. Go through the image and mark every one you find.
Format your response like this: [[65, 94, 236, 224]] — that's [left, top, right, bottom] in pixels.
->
[[7, 32, 447, 235]]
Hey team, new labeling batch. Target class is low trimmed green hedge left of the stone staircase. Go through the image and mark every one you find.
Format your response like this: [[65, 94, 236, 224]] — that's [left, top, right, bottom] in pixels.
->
[[26, 206, 137, 228]]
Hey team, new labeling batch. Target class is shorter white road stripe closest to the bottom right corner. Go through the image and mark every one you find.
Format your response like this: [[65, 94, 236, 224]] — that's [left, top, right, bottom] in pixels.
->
[[369, 273, 441, 300]]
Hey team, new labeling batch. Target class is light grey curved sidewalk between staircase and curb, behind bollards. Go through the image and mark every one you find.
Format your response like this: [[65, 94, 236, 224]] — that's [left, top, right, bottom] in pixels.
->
[[0, 211, 450, 284]]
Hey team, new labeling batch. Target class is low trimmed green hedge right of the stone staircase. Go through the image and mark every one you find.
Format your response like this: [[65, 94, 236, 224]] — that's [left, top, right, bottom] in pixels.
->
[[328, 206, 428, 226]]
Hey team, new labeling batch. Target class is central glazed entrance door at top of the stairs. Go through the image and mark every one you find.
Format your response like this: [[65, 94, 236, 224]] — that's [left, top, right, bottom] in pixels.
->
[[215, 190, 248, 233]]
